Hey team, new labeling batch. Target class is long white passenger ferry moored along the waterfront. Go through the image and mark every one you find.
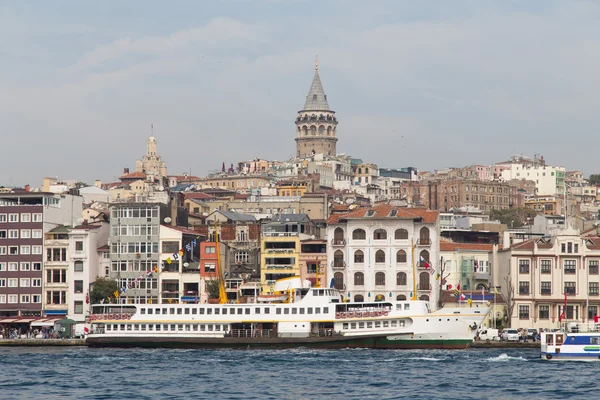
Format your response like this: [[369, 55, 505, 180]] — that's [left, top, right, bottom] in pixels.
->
[[86, 278, 489, 349]]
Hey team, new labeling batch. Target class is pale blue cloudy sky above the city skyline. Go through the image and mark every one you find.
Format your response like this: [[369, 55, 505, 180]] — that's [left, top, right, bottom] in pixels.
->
[[0, 0, 600, 186]]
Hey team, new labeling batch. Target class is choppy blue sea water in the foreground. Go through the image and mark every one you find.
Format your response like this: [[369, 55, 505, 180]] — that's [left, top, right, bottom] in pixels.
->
[[0, 347, 600, 400]]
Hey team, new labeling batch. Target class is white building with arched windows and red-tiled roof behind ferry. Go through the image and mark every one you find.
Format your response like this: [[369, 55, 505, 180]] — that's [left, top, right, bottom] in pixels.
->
[[327, 204, 440, 308]]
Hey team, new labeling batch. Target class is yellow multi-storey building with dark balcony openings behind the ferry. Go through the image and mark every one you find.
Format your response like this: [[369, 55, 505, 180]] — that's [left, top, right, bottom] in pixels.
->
[[260, 232, 300, 293]]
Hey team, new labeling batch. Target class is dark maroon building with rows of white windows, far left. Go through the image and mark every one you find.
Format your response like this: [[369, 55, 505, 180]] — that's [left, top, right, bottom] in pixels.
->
[[0, 189, 82, 317]]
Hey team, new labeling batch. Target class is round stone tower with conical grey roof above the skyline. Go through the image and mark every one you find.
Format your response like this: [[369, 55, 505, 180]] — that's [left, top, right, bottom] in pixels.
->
[[296, 58, 337, 157]]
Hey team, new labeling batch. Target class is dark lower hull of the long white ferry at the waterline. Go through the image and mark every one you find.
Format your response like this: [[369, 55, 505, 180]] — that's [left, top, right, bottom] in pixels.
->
[[86, 335, 472, 349]]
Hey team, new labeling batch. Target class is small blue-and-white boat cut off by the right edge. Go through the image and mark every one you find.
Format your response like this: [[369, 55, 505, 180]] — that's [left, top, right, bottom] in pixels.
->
[[540, 323, 600, 361]]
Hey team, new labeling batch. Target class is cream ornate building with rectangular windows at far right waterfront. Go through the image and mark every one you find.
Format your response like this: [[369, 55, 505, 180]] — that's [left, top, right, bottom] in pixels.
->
[[498, 227, 600, 329]]
